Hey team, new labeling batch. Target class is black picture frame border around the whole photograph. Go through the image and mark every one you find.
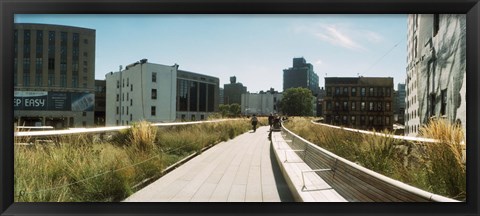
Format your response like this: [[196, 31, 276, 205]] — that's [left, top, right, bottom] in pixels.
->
[[0, 0, 480, 215]]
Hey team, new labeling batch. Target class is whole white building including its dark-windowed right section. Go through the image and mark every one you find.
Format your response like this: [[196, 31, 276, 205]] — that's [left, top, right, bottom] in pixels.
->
[[106, 59, 219, 125]]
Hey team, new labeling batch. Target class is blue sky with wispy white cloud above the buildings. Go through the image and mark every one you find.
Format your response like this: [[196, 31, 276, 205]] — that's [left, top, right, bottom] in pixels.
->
[[15, 14, 407, 93]]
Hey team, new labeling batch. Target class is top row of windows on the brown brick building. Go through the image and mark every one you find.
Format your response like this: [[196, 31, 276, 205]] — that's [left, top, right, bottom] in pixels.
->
[[327, 87, 392, 97]]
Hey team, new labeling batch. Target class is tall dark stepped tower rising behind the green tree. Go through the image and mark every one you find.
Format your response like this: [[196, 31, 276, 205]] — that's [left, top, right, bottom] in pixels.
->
[[283, 57, 319, 96]]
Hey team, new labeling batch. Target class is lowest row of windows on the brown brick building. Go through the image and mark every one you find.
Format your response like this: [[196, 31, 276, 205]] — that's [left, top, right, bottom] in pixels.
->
[[326, 115, 391, 126]]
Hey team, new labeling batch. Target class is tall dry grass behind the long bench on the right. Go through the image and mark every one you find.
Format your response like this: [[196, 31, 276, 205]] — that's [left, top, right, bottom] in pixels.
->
[[285, 117, 466, 200]]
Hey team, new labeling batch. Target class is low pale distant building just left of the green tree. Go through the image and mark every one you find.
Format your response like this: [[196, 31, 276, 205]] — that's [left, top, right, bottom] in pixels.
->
[[241, 92, 282, 115]]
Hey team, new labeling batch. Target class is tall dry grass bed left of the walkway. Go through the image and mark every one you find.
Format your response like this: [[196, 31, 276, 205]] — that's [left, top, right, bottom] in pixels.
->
[[14, 119, 250, 202]]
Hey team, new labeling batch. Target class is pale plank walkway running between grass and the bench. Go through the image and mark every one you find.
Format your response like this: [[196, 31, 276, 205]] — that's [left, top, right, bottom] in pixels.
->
[[125, 127, 293, 202]]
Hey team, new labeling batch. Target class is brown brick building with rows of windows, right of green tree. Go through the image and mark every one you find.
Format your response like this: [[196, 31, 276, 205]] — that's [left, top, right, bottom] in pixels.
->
[[323, 77, 393, 130]]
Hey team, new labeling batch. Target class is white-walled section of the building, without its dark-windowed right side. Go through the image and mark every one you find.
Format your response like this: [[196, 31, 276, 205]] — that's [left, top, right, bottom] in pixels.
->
[[105, 59, 178, 126]]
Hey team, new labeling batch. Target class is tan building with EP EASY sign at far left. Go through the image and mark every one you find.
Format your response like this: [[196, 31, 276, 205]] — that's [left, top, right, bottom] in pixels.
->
[[13, 23, 95, 129]]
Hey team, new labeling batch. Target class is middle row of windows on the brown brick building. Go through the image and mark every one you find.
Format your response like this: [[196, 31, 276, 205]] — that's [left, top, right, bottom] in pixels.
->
[[326, 101, 391, 112]]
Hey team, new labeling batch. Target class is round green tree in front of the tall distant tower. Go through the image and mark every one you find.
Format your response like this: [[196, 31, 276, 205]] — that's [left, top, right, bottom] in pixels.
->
[[280, 88, 314, 116]]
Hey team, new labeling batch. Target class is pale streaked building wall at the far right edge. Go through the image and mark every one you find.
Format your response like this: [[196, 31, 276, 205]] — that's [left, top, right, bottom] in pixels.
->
[[418, 14, 466, 128]]
